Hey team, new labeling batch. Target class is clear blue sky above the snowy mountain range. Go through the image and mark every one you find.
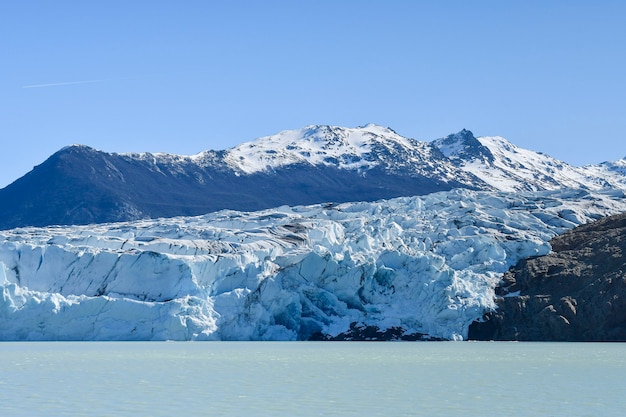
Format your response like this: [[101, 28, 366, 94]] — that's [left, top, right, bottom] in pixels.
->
[[0, 0, 626, 187]]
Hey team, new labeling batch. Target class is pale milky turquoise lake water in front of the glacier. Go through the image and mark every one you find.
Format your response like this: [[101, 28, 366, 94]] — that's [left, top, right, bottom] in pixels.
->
[[0, 342, 626, 417]]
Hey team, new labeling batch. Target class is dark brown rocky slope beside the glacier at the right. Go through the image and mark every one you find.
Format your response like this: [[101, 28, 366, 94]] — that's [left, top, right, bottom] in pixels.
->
[[469, 213, 626, 341]]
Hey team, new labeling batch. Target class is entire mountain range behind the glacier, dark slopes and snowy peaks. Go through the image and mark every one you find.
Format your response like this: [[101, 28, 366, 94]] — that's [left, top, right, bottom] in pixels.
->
[[0, 125, 626, 229]]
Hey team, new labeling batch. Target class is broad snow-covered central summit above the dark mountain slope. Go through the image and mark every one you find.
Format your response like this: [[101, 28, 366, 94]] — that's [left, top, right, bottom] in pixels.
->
[[225, 124, 454, 177]]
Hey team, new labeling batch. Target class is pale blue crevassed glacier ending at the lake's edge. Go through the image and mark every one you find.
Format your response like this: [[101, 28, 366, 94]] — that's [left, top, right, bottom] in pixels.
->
[[0, 190, 626, 340]]
